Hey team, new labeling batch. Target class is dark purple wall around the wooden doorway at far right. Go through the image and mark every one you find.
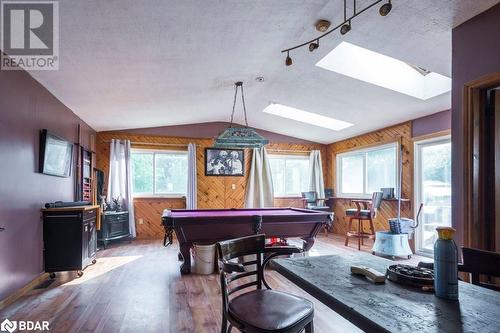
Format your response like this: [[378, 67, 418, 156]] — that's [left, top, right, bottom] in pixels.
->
[[451, 4, 500, 244]]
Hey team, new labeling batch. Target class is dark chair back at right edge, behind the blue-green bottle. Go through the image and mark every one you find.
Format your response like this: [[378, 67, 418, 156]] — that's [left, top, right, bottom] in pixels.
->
[[458, 247, 500, 291]]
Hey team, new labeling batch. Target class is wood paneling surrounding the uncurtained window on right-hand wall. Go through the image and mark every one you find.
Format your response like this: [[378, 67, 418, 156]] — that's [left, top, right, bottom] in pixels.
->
[[325, 122, 414, 235]]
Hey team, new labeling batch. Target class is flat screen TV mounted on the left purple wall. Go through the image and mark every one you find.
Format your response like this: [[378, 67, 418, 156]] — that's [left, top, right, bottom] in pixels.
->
[[39, 129, 73, 177]]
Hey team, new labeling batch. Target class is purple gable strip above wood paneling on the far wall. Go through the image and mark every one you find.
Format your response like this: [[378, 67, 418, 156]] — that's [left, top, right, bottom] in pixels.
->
[[110, 121, 315, 144]]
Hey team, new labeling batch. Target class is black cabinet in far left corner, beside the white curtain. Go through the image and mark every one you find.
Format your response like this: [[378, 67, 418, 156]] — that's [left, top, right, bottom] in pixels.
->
[[97, 211, 130, 248]]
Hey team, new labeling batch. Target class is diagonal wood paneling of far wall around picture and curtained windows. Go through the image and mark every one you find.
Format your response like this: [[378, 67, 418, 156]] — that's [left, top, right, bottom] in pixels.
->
[[96, 132, 327, 238]]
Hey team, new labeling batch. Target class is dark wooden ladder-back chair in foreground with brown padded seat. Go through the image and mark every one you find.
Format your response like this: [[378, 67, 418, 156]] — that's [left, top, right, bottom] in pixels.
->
[[217, 235, 314, 333]]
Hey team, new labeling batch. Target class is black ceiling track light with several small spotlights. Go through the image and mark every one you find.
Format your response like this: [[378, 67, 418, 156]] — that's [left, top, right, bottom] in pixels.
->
[[281, 0, 392, 66]]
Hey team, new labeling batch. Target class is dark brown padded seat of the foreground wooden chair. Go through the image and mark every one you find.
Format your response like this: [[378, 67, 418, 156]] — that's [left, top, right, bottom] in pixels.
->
[[229, 289, 314, 331]]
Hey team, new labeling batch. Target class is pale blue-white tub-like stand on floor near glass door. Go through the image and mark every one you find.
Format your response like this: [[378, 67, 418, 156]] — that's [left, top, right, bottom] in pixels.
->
[[372, 231, 413, 259]]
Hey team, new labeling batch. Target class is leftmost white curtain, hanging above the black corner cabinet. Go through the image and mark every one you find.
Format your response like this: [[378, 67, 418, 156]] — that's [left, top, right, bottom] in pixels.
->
[[107, 139, 136, 238]]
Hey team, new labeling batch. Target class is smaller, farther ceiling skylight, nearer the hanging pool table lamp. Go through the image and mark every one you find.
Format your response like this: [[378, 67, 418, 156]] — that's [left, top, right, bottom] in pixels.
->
[[263, 103, 353, 131]]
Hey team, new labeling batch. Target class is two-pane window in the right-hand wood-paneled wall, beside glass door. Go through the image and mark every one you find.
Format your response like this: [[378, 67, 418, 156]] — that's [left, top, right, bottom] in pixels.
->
[[337, 143, 398, 198]]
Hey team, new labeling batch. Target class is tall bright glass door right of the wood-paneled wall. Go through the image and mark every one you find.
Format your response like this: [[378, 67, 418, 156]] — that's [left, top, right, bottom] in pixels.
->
[[415, 136, 451, 255]]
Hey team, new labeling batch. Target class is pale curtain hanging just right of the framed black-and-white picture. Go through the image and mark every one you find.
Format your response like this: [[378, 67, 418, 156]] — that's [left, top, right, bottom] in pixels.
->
[[245, 147, 274, 208]]
